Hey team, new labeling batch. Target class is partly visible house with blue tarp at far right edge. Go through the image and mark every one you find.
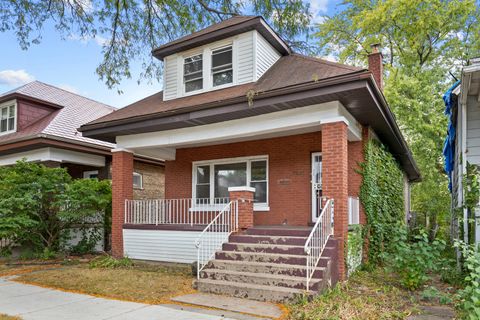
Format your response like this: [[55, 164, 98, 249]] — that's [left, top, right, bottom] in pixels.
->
[[443, 58, 480, 245]]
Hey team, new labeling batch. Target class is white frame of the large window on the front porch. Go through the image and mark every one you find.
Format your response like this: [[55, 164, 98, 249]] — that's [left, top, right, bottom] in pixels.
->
[[192, 155, 270, 211]]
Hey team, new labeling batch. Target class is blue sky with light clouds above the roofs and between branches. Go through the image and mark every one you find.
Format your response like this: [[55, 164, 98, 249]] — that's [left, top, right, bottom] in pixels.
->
[[0, 0, 335, 108]]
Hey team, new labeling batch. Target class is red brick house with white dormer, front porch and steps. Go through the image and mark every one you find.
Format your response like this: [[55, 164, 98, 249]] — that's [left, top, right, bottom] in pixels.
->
[[80, 16, 420, 300]]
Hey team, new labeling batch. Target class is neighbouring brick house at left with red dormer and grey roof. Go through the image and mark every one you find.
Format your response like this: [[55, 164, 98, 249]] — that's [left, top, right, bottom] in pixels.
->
[[0, 81, 164, 199]]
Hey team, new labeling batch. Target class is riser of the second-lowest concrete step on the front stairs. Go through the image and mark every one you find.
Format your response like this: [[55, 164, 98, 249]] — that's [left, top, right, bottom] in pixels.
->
[[200, 271, 322, 290]]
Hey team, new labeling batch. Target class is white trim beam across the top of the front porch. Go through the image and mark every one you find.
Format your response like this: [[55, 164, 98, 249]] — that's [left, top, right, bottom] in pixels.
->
[[117, 101, 362, 160]]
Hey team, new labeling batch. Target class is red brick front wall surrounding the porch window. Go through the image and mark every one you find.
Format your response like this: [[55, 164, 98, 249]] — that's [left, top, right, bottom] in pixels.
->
[[165, 132, 322, 226]]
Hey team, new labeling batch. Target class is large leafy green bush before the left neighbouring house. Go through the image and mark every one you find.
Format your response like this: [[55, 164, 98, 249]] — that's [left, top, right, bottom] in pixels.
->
[[0, 161, 111, 255]]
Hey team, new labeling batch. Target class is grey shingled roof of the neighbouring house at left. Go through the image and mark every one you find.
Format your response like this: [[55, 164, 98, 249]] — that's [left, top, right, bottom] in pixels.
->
[[0, 81, 115, 148]]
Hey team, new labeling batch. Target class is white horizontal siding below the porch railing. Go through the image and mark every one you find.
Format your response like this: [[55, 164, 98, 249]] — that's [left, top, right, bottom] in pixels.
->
[[123, 229, 229, 263]]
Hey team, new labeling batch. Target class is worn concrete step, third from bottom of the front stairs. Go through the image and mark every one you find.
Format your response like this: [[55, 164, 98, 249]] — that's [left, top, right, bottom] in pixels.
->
[[207, 259, 326, 279]]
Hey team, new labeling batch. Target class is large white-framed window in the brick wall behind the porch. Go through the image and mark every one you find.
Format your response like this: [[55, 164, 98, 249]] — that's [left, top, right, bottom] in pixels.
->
[[193, 156, 268, 211]]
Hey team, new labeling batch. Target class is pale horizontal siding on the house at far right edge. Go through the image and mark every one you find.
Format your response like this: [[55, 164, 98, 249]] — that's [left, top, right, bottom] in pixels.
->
[[467, 96, 480, 165]]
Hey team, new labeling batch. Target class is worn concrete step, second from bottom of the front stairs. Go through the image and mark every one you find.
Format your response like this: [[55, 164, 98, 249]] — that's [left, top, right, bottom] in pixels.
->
[[200, 269, 323, 291]]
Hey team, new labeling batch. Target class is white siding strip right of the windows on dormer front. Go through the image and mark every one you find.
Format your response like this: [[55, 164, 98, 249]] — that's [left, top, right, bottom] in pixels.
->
[[236, 31, 255, 84]]
